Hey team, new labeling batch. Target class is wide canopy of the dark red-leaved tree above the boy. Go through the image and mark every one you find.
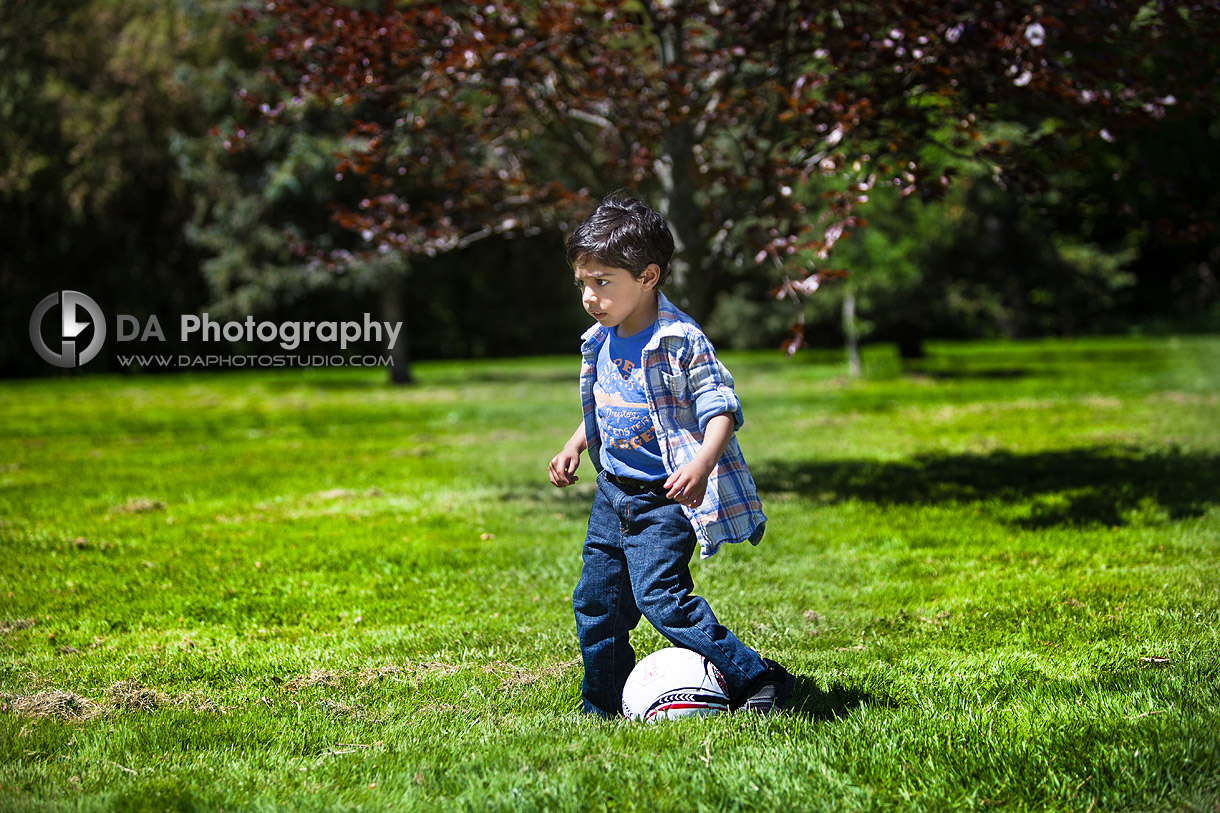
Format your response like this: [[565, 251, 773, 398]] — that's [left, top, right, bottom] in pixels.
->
[[237, 0, 1220, 356]]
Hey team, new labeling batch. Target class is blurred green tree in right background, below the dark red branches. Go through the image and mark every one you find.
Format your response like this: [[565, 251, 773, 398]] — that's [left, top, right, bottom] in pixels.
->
[[804, 170, 1136, 359]]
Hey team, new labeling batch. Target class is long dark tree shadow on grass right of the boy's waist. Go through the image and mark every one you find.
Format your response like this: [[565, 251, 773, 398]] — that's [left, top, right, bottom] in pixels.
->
[[752, 447, 1220, 527]]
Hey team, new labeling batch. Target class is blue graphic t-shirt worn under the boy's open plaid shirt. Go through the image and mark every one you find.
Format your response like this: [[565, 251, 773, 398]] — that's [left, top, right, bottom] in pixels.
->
[[593, 322, 666, 481]]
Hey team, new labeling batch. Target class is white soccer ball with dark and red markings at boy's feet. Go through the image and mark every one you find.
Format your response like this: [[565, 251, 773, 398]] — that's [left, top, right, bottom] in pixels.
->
[[622, 647, 728, 723]]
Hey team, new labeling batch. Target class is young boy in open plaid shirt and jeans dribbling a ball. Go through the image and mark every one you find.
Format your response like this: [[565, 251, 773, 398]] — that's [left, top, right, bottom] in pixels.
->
[[549, 192, 794, 717]]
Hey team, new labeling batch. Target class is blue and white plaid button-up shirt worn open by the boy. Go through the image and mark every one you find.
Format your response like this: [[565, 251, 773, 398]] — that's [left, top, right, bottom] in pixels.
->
[[581, 292, 766, 559]]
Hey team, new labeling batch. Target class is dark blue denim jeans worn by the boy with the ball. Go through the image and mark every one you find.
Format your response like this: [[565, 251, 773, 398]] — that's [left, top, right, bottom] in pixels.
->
[[572, 472, 766, 717]]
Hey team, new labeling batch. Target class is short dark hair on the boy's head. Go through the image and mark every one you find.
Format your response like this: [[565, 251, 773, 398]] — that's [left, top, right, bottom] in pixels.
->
[[567, 189, 673, 286]]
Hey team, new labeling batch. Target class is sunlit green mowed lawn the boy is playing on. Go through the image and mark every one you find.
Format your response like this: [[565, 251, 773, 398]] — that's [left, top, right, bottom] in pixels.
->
[[0, 338, 1220, 812]]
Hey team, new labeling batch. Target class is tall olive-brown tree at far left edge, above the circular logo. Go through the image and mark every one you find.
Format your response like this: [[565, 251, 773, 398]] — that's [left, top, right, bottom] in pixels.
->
[[0, 0, 215, 375]]
